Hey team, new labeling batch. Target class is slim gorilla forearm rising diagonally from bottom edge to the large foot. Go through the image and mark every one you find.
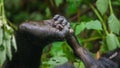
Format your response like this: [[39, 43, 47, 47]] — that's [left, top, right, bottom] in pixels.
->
[[66, 29, 99, 68]]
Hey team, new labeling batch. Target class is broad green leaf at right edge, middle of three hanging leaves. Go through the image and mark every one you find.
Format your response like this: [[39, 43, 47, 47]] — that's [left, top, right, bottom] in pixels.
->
[[108, 14, 120, 34]]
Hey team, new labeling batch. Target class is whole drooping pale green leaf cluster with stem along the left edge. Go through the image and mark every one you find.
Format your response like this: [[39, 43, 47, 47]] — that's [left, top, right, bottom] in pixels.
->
[[0, 0, 17, 66]]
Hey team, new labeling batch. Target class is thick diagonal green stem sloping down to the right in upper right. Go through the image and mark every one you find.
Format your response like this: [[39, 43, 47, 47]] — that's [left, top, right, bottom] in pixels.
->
[[89, 4, 108, 35]]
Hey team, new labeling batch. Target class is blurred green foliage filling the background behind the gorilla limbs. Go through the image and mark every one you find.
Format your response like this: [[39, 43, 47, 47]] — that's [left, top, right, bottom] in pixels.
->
[[0, 0, 120, 68]]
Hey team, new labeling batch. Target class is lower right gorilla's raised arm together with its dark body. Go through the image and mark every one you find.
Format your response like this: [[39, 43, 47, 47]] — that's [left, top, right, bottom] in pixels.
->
[[66, 31, 120, 68]]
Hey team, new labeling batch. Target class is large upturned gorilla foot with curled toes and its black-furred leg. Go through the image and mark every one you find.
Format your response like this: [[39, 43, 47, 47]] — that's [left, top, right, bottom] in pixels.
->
[[3, 15, 73, 68]]
